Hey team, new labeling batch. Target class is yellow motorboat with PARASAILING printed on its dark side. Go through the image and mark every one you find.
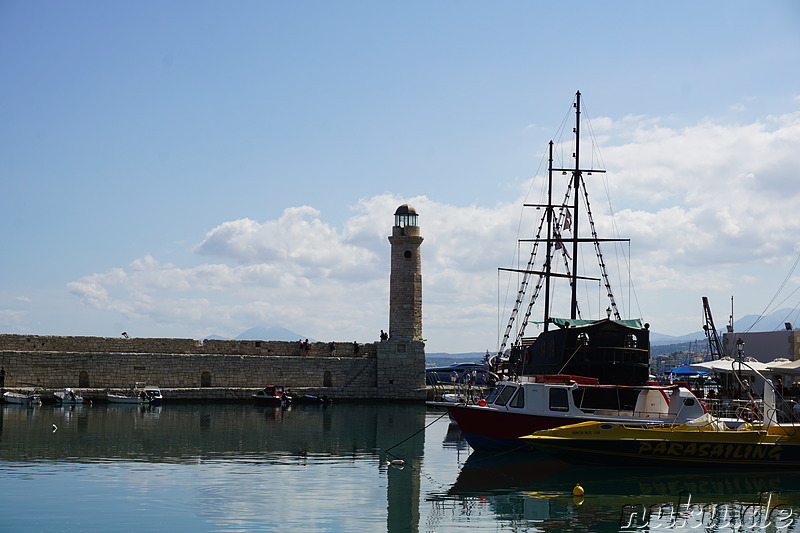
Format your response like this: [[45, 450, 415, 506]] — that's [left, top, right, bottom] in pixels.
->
[[520, 380, 800, 469]]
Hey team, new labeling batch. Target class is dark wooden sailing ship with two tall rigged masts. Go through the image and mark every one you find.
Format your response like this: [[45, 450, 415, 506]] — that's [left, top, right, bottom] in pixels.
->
[[496, 91, 650, 386]]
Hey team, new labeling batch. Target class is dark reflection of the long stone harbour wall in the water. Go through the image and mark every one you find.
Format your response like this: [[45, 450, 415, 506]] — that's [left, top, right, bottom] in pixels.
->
[[0, 404, 424, 462]]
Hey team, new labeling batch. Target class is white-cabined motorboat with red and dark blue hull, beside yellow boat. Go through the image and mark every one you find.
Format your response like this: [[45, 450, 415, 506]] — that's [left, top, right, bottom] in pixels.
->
[[438, 374, 706, 450]]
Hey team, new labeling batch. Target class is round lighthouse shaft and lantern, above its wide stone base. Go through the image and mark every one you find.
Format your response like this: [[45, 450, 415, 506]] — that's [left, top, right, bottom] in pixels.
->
[[389, 204, 422, 341]]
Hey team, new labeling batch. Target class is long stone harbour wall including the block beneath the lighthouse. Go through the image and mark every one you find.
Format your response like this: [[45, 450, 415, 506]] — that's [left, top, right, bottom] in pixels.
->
[[0, 335, 425, 400]]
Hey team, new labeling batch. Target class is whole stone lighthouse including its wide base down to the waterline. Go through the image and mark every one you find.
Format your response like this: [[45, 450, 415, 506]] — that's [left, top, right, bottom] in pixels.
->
[[376, 204, 425, 400]]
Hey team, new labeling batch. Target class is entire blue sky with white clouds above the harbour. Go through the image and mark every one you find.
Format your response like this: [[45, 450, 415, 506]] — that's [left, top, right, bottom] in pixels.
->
[[0, 1, 800, 352]]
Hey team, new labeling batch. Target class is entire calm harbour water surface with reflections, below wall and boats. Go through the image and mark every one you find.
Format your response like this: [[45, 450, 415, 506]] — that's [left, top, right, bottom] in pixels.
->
[[0, 402, 800, 532]]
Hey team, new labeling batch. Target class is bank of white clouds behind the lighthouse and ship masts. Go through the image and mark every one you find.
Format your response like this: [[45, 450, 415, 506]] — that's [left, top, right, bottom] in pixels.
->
[[64, 114, 800, 352]]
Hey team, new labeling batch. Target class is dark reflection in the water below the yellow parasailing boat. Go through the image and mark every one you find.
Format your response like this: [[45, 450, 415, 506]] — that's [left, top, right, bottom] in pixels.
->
[[427, 416, 800, 531]]
